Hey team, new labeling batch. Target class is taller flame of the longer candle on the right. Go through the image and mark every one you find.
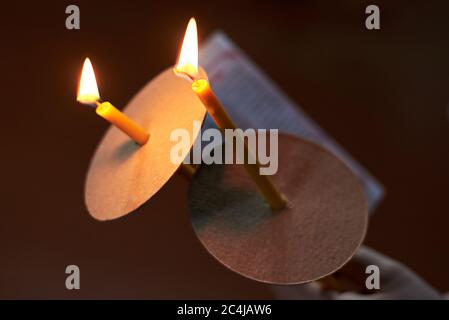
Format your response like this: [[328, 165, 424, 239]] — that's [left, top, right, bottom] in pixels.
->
[[175, 18, 198, 79]]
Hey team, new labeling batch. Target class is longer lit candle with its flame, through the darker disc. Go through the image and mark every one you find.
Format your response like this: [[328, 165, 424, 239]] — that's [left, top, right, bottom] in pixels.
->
[[174, 18, 286, 210]]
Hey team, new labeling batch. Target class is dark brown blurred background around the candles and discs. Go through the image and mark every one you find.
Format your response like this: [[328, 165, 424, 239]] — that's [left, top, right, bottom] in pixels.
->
[[0, 1, 449, 298]]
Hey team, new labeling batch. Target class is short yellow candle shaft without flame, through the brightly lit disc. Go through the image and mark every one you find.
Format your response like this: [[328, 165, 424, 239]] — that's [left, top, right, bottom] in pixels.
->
[[96, 102, 150, 145]]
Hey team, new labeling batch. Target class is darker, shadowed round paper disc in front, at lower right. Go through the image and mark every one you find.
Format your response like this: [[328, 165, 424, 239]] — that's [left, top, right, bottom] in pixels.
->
[[189, 134, 368, 284]]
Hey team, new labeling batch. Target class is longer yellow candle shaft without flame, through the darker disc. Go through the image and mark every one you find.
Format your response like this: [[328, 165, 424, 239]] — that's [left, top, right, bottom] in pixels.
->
[[192, 79, 286, 210]]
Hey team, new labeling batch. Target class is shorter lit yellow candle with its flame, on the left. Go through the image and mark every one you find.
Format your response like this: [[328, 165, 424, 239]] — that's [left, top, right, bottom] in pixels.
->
[[77, 58, 150, 145]]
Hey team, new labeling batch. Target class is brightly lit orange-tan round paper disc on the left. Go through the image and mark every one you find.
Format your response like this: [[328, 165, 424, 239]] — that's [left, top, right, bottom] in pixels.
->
[[85, 69, 206, 220]]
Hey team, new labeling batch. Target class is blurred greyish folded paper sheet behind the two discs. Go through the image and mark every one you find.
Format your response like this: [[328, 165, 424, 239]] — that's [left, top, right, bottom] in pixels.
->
[[200, 32, 384, 212]]
